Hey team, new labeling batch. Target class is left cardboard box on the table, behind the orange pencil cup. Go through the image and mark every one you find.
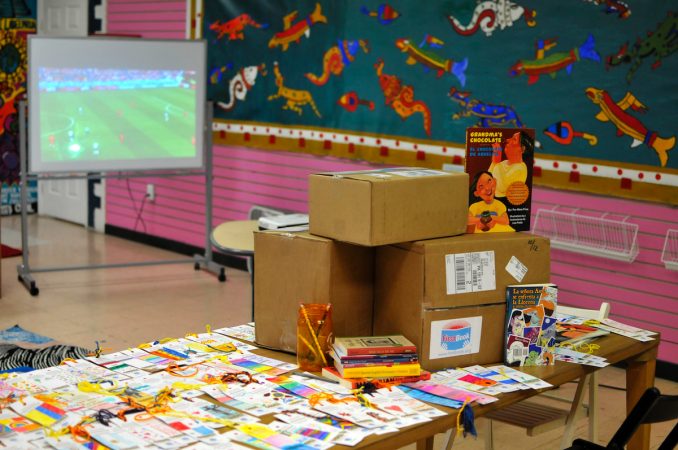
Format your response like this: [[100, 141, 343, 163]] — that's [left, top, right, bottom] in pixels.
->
[[254, 231, 374, 353]]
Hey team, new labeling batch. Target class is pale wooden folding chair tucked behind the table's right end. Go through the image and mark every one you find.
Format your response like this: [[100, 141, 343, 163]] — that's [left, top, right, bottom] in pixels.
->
[[483, 302, 610, 450]]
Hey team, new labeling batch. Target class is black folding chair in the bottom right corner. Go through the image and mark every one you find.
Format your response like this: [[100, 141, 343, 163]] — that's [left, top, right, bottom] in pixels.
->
[[568, 388, 678, 450]]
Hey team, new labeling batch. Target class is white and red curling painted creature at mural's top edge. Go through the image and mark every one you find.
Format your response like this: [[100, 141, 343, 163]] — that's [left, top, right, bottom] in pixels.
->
[[447, 0, 537, 36]]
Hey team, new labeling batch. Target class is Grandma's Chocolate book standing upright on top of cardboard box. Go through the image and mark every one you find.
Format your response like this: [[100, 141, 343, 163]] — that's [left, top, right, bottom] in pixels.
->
[[464, 127, 535, 233]]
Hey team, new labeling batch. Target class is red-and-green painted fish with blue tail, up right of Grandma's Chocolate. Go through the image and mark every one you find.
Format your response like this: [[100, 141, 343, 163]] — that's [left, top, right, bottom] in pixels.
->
[[509, 34, 600, 84]]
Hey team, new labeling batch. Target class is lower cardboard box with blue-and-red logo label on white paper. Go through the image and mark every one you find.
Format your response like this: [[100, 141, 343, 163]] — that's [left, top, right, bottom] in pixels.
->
[[374, 303, 506, 370]]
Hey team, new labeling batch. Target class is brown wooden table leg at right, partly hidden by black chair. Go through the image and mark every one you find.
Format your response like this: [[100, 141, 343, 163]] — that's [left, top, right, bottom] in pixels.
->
[[626, 347, 657, 450]]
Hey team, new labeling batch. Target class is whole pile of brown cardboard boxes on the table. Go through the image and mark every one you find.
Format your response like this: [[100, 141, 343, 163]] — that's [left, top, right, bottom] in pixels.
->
[[255, 168, 550, 370]]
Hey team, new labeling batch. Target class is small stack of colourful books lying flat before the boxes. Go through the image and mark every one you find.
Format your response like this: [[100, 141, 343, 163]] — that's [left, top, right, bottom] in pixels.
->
[[322, 335, 430, 385]]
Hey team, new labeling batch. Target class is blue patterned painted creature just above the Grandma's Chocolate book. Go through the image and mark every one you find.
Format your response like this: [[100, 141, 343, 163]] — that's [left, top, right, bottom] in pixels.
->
[[447, 88, 523, 128]]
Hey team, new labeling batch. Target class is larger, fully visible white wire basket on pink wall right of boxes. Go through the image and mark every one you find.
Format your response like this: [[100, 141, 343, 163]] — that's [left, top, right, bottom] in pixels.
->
[[532, 206, 639, 262]]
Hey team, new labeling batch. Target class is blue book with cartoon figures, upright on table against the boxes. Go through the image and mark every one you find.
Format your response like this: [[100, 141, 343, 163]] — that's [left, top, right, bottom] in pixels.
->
[[504, 283, 558, 366]]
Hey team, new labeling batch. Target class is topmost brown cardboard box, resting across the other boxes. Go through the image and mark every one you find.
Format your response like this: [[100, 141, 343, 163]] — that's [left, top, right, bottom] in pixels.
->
[[309, 167, 468, 246]]
